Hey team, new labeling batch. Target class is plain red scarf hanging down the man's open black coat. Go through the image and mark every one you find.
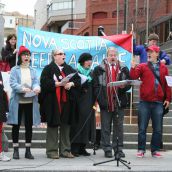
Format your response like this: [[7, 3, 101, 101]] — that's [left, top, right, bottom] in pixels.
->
[[56, 71, 67, 113]]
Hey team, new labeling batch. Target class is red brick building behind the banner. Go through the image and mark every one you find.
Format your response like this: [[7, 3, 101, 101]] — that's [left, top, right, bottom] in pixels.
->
[[68, 0, 172, 41]]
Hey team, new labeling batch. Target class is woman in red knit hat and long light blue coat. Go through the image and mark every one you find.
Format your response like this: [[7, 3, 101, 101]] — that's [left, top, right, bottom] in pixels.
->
[[7, 46, 40, 159]]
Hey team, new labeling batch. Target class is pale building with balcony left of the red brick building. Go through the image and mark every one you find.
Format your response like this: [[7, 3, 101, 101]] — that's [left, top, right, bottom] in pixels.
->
[[35, 0, 86, 34]]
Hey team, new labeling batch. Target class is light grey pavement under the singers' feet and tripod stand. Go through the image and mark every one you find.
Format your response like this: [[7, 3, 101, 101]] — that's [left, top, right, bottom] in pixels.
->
[[0, 148, 172, 172]]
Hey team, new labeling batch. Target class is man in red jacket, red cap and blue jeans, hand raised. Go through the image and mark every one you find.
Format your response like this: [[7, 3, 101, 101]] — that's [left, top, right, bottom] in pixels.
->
[[130, 45, 171, 158]]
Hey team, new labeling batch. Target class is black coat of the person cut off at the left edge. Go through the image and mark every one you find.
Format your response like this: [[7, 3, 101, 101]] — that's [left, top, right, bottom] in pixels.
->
[[0, 72, 8, 122]]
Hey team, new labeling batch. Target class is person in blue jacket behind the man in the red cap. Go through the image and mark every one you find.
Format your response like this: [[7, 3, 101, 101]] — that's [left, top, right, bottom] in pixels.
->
[[133, 33, 170, 65]]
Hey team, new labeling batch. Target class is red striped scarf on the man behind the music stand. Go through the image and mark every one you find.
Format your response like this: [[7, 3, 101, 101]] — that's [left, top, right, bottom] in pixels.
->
[[103, 59, 119, 112]]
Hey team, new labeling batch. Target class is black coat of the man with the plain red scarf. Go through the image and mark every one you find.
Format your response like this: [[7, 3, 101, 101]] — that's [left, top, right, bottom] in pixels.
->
[[39, 62, 81, 127]]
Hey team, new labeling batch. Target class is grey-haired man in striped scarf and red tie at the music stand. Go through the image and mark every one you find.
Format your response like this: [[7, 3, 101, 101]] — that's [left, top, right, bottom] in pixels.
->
[[93, 47, 130, 158]]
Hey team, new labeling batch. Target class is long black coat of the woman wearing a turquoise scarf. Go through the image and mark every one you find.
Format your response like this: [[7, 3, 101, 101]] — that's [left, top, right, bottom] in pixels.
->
[[70, 79, 96, 144]]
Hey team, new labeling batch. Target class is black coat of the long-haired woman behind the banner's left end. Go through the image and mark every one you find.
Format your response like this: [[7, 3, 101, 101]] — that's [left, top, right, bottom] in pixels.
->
[[1, 46, 16, 68]]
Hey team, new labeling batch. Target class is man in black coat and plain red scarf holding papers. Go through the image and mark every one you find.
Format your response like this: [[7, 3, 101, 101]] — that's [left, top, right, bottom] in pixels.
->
[[39, 49, 80, 159]]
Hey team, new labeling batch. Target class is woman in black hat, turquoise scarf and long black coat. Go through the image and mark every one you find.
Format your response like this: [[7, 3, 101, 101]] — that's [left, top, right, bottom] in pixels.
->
[[71, 53, 95, 156]]
